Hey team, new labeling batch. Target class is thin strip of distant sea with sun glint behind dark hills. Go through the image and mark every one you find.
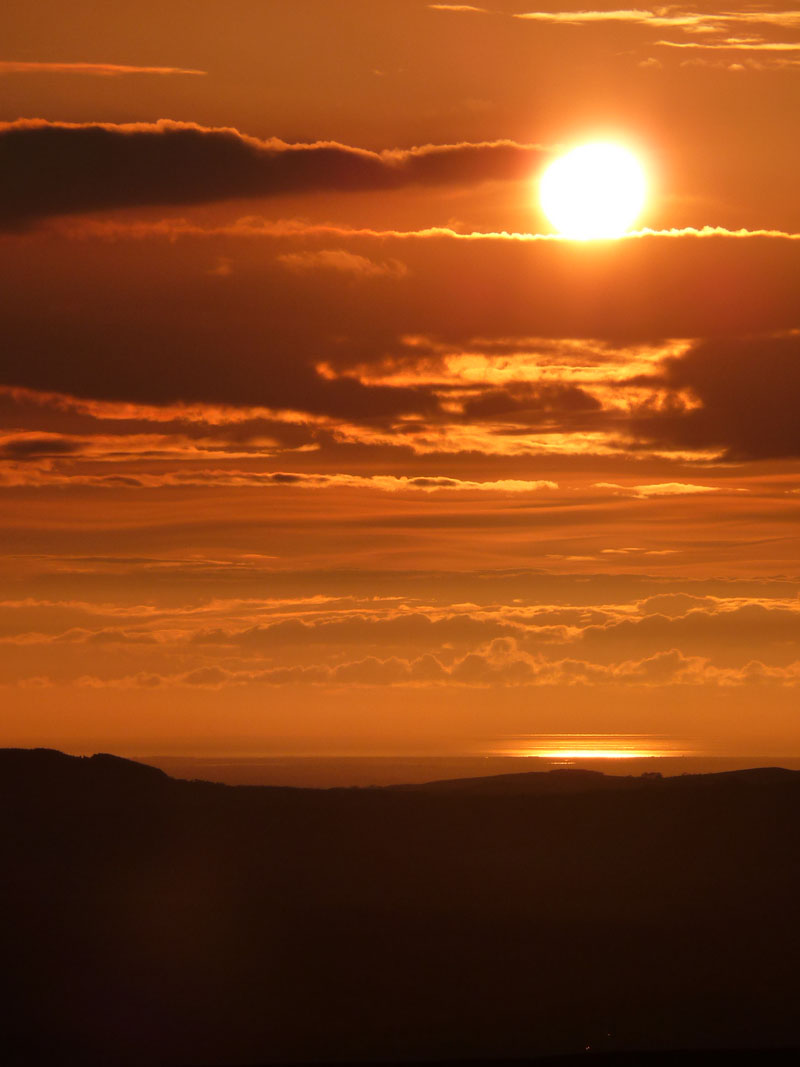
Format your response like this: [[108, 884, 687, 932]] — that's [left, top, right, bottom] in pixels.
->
[[130, 754, 800, 789]]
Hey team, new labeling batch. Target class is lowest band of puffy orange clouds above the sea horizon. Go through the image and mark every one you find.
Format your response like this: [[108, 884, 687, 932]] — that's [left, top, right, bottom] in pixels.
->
[[6, 582, 800, 689]]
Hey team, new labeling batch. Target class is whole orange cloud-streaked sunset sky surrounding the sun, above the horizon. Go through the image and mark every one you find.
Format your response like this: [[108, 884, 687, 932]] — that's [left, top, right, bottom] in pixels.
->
[[0, 0, 800, 757]]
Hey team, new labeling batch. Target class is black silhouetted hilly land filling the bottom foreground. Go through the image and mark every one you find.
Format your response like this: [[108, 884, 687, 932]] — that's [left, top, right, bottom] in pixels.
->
[[0, 750, 800, 1067]]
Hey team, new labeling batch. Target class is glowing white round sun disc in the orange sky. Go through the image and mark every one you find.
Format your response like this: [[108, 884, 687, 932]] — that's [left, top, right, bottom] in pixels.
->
[[539, 142, 646, 241]]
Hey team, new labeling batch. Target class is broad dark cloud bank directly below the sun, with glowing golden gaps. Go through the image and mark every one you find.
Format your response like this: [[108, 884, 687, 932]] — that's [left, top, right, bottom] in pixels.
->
[[0, 232, 800, 460]]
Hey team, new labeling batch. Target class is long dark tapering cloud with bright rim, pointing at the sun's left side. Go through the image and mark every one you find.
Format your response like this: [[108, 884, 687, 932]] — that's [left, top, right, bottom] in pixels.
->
[[0, 120, 545, 226]]
